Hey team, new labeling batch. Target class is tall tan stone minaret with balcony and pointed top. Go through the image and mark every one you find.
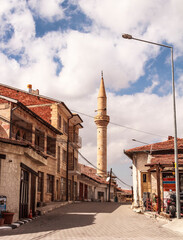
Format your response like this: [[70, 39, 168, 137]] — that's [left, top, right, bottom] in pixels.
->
[[95, 72, 109, 178]]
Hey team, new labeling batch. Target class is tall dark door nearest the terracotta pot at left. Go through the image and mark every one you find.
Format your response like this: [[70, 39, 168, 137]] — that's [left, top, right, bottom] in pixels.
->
[[19, 169, 29, 218]]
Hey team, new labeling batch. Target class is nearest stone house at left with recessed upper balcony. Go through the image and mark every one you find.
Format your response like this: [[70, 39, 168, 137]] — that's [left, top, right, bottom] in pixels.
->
[[0, 96, 62, 219]]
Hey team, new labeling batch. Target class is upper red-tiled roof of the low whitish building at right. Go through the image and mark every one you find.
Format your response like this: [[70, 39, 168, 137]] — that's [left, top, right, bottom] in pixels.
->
[[125, 137, 183, 154]]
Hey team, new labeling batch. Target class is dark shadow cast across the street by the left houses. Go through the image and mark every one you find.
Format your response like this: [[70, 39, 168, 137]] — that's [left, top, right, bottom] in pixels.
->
[[0, 202, 126, 236]]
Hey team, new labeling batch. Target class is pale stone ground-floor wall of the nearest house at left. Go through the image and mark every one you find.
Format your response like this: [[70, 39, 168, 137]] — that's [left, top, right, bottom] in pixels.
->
[[0, 143, 44, 221]]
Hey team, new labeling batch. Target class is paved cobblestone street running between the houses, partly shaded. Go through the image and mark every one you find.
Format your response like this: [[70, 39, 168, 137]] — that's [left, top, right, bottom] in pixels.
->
[[0, 203, 183, 240]]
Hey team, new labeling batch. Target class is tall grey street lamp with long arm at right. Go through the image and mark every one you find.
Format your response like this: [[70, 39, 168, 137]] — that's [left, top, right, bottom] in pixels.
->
[[122, 34, 181, 219]]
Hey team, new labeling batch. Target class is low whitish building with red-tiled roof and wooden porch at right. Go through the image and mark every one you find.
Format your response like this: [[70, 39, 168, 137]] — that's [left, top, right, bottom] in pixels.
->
[[124, 136, 183, 212]]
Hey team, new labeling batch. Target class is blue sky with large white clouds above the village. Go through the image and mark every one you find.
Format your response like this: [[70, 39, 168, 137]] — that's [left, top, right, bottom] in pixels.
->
[[0, 0, 183, 188]]
